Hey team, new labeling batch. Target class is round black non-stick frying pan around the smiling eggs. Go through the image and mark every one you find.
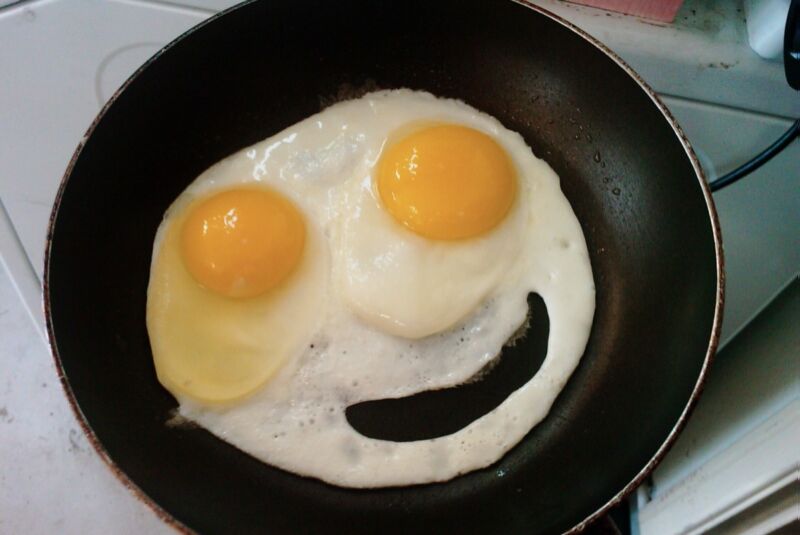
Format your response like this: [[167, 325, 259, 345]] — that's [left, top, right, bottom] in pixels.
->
[[45, 0, 723, 534]]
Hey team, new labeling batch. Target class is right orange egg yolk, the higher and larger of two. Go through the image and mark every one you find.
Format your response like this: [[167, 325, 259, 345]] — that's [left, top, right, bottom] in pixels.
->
[[376, 125, 516, 240]]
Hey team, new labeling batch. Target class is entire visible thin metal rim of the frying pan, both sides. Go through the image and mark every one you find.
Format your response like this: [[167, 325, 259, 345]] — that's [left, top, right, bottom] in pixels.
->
[[43, 0, 725, 534]]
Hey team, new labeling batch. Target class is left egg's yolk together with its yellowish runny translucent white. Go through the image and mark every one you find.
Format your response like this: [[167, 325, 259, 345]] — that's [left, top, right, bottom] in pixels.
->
[[147, 183, 329, 403]]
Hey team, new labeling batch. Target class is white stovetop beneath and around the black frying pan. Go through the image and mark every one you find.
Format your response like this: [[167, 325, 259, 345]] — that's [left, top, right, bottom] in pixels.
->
[[0, 0, 800, 534]]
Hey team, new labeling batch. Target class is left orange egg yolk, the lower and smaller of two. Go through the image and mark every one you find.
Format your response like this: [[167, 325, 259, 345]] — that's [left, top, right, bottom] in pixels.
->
[[181, 188, 305, 298]]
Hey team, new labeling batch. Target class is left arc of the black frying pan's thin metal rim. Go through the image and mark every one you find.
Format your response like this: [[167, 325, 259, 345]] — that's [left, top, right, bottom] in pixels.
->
[[42, 0, 256, 535]]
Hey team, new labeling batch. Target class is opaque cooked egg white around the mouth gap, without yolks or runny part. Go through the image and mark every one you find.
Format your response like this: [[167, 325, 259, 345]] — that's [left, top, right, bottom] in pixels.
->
[[148, 90, 594, 487]]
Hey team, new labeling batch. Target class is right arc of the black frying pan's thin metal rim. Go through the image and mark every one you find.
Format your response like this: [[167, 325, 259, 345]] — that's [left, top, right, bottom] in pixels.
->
[[513, 0, 725, 534]]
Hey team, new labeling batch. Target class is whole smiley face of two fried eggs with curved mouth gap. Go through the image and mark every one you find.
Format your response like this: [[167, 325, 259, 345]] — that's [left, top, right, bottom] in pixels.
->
[[147, 90, 595, 487]]
